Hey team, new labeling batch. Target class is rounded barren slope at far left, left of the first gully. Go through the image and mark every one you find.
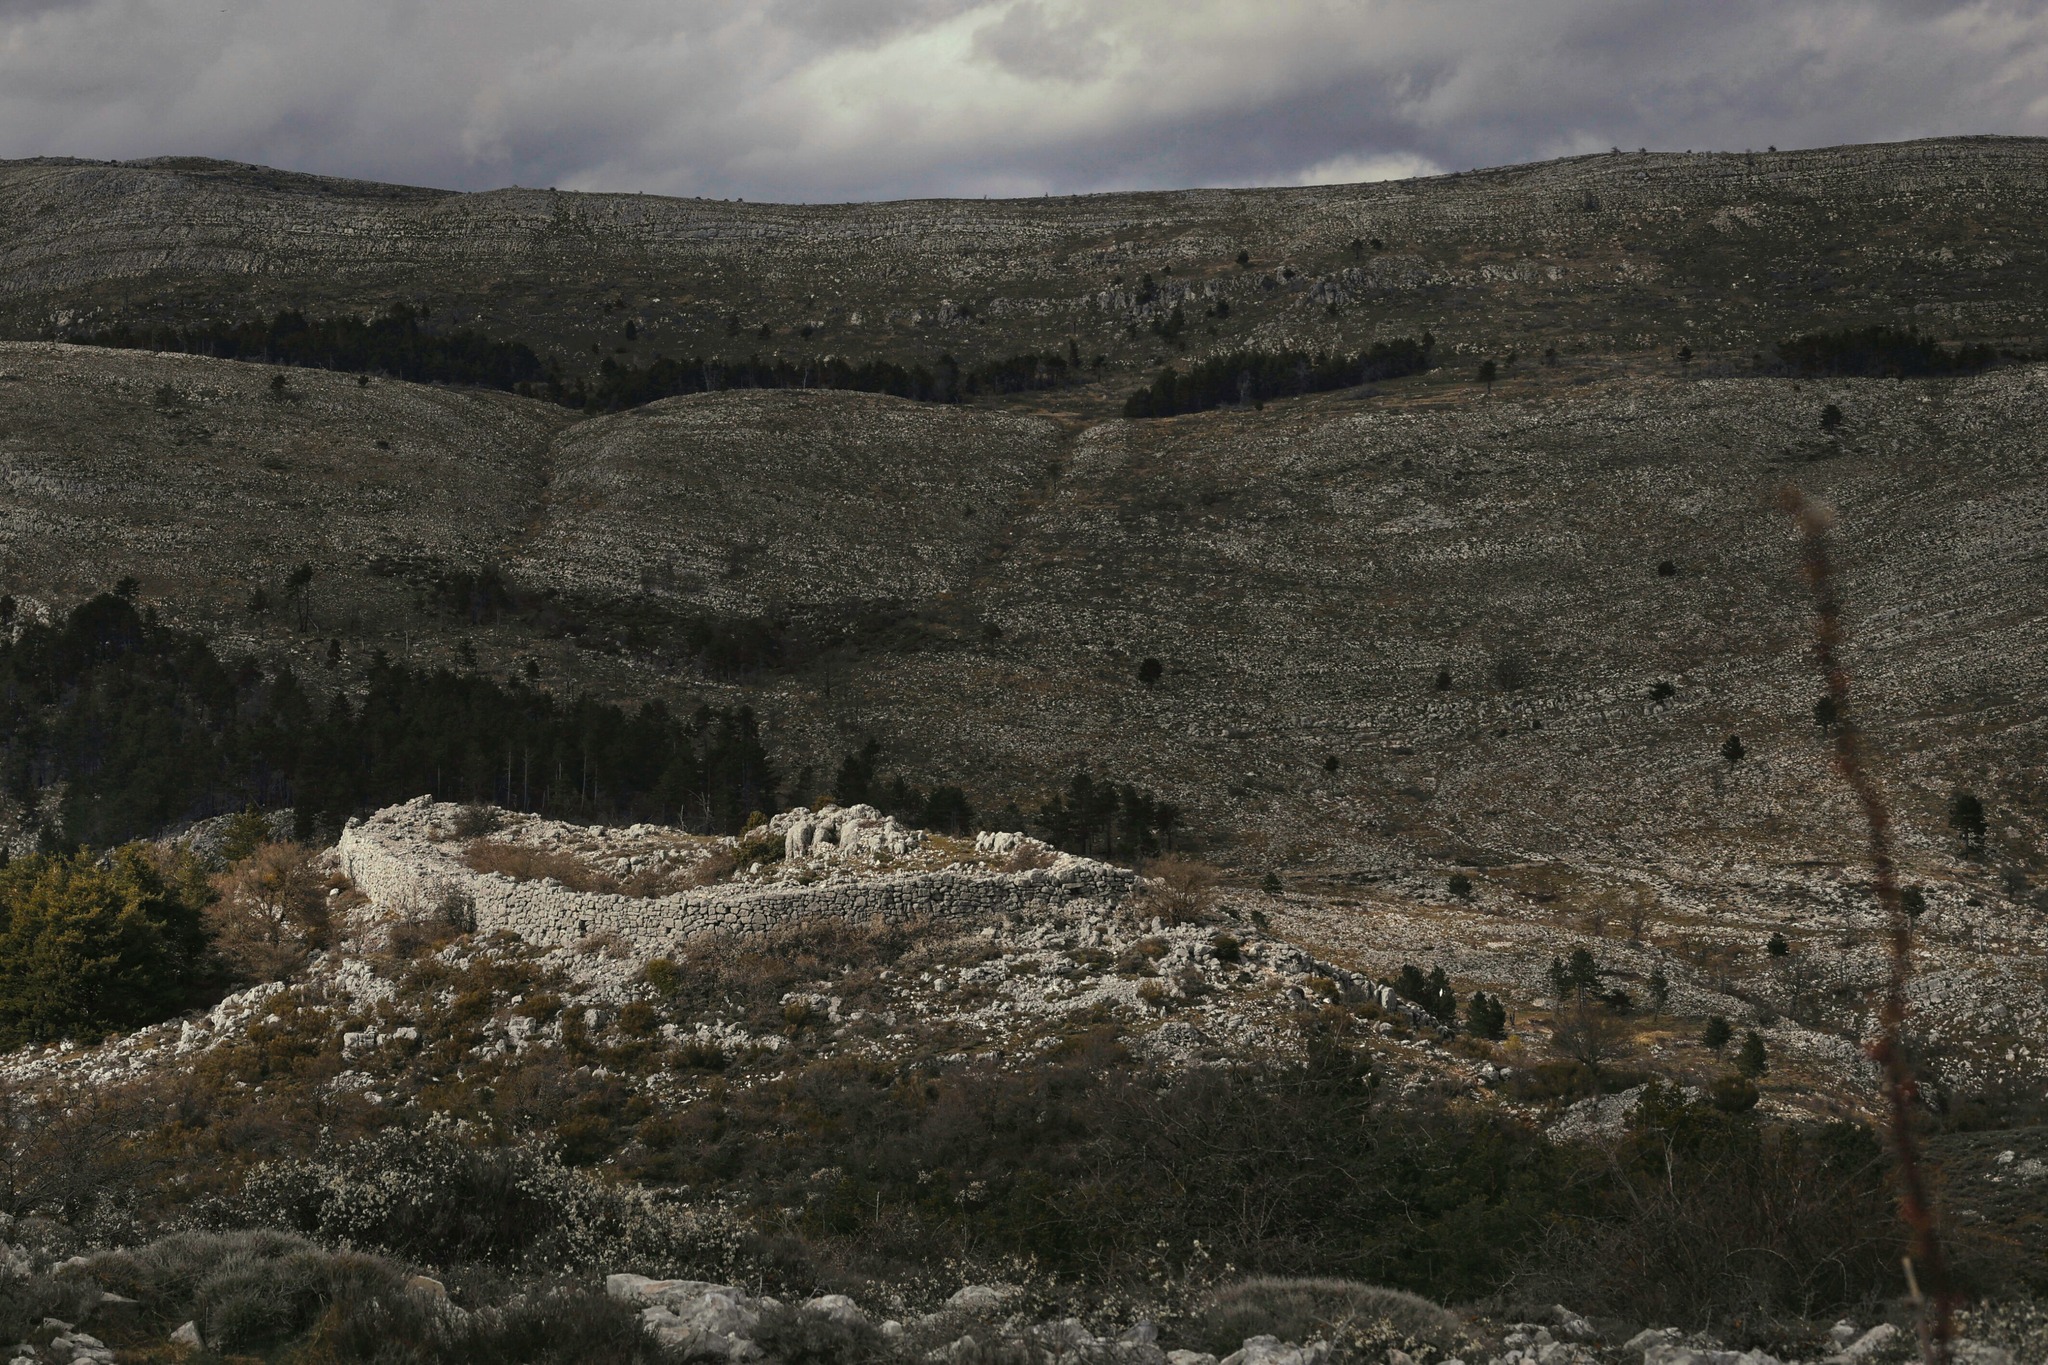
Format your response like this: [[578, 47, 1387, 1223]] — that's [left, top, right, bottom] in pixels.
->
[[0, 344, 569, 650]]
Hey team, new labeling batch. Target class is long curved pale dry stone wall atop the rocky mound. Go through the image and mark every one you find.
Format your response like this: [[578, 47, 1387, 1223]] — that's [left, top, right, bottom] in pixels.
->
[[338, 796, 1137, 956]]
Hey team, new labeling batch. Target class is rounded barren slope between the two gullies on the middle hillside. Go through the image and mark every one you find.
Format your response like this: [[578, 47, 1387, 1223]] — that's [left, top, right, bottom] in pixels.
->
[[516, 391, 1063, 616]]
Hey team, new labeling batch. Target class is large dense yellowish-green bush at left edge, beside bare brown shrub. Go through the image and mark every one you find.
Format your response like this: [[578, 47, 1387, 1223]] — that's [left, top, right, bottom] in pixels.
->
[[0, 843, 207, 1046]]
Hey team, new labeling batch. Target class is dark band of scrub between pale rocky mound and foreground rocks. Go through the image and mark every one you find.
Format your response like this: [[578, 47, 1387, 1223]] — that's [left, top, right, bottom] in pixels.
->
[[0, 1002, 1896, 1322]]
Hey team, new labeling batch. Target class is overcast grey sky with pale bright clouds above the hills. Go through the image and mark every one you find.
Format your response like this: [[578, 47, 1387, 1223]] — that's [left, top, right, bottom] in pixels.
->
[[0, 0, 2048, 201]]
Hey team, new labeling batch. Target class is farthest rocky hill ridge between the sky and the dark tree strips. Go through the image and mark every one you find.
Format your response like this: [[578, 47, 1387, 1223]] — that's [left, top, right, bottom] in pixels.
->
[[0, 139, 2048, 386]]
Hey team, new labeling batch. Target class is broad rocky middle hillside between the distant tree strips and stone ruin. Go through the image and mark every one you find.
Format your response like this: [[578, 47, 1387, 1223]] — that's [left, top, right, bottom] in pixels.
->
[[0, 331, 2048, 900]]
